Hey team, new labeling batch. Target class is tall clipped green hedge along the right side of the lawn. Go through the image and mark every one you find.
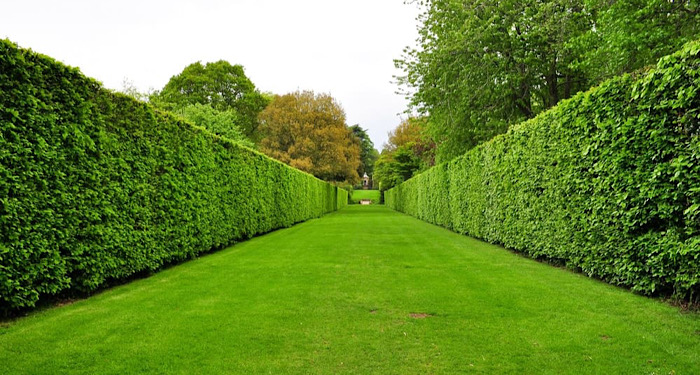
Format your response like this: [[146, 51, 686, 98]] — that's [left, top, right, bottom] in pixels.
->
[[385, 42, 700, 300]]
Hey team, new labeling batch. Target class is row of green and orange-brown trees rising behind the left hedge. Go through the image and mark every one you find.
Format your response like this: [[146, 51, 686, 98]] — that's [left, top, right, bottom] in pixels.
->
[[123, 60, 378, 184]]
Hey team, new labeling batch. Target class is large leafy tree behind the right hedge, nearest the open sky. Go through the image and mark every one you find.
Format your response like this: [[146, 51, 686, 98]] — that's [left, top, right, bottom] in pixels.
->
[[397, 0, 589, 161]]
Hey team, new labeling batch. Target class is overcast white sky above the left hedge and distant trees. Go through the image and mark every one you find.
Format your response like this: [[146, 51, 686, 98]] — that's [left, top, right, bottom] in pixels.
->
[[0, 0, 419, 149]]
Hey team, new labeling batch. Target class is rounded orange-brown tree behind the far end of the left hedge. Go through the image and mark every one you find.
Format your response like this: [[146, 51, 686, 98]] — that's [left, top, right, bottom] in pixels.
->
[[259, 91, 360, 184]]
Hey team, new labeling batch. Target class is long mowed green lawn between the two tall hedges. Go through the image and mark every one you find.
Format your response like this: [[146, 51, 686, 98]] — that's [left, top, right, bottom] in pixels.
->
[[0, 206, 700, 374]]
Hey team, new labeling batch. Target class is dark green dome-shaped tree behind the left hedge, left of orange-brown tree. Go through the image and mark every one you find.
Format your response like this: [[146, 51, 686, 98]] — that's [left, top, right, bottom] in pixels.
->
[[150, 60, 268, 140]]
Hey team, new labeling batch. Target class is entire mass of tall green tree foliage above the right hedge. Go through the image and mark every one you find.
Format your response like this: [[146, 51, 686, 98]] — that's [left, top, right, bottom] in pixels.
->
[[396, 0, 700, 161]]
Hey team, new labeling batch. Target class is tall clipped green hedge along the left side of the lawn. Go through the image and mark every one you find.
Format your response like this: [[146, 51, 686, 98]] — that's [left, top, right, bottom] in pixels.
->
[[0, 41, 347, 311]]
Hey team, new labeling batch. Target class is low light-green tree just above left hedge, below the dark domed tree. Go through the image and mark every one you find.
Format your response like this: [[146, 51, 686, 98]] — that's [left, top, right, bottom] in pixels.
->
[[175, 103, 255, 148]]
